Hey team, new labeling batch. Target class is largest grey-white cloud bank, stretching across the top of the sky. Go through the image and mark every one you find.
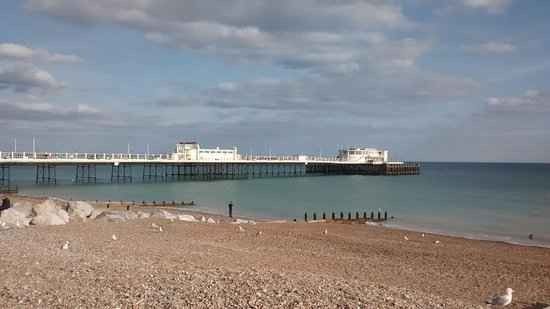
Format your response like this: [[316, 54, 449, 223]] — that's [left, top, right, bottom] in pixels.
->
[[26, 0, 414, 72]]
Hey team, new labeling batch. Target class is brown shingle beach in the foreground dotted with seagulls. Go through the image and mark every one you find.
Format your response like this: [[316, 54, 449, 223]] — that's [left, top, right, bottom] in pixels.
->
[[0, 195, 550, 308]]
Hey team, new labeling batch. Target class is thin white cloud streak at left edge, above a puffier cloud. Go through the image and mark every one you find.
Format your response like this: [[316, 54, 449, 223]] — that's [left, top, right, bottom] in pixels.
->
[[0, 43, 82, 63]]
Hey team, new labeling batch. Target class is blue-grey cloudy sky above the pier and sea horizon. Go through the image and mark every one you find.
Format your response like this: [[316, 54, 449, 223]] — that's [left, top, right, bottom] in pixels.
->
[[0, 0, 550, 162]]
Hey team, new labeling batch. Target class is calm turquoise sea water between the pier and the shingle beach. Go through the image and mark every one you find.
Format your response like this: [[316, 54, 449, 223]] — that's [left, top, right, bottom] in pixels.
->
[[10, 163, 550, 246]]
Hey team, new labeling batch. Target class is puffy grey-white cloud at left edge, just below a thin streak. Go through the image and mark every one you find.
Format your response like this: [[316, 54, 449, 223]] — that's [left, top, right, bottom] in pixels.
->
[[0, 63, 64, 92]]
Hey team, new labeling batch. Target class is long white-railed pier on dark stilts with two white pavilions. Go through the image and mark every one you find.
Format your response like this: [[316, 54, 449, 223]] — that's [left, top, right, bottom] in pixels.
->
[[0, 143, 420, 185]]
